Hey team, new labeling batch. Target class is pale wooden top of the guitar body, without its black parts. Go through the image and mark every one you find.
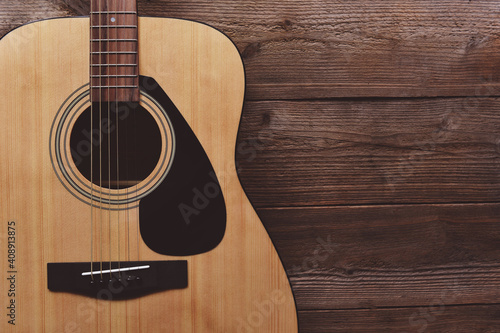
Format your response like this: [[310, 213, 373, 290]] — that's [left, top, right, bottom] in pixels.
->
[[0, 17, 297, 332]]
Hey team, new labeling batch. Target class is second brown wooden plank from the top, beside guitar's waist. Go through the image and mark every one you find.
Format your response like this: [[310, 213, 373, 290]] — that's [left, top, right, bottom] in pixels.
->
[[237, 98, 500, 207]]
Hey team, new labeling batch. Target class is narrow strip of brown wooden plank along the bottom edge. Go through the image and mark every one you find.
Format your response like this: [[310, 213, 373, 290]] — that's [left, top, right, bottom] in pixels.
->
[[300, 301, 500, 333]]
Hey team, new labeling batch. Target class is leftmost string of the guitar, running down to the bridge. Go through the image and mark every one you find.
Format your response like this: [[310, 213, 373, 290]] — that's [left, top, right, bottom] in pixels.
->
[[89, 0, 94, 281]]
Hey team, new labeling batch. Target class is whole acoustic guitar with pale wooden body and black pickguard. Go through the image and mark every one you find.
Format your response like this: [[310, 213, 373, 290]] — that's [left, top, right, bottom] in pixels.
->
[[0, 0, 297, 333]]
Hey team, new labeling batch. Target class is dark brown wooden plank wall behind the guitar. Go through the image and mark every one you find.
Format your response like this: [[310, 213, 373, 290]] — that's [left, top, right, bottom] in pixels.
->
[[0, 0, 500, 332]]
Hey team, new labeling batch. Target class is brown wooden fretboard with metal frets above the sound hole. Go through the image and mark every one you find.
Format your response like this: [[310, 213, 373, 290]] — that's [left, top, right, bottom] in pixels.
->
[[90, 0, 139, 102]]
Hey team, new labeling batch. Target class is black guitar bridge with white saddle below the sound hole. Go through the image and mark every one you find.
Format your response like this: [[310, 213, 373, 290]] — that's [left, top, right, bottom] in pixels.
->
[[47, 260, 188, 301]]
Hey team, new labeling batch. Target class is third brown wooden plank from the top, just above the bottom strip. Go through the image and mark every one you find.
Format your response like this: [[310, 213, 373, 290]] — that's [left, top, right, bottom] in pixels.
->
[[259, 204, 500, 310]]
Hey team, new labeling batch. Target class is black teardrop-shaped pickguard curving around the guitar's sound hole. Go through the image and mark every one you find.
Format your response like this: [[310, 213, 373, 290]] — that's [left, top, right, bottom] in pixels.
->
[[139, 76, 226, 256]]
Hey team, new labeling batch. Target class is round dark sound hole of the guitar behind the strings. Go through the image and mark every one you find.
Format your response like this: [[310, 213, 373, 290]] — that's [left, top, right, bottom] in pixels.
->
[[70, 103, 162, 189]]
